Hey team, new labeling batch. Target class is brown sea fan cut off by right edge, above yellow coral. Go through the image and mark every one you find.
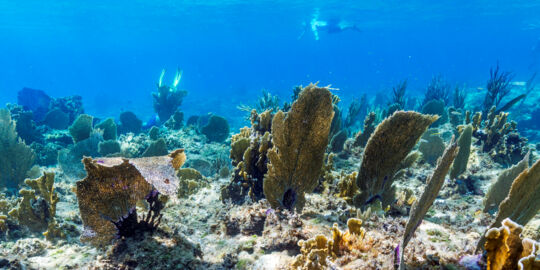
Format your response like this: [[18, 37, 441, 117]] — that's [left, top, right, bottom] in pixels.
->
[[477, 157, 540, 252]]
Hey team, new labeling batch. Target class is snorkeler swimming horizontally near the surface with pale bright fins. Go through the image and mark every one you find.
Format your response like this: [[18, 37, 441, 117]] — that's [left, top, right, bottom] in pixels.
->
[[298, 10, 361, 40]]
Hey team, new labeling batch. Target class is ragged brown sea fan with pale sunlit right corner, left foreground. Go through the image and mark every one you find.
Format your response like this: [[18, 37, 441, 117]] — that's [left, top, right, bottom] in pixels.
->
[[77, 149, 186, 246]]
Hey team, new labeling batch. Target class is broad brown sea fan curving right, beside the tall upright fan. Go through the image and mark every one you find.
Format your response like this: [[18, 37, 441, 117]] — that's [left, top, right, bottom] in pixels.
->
[[355, 111, 438, 206]]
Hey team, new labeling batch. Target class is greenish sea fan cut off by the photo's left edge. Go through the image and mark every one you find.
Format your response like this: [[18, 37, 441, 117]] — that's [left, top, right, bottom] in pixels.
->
[[0, 109, 35, 188]]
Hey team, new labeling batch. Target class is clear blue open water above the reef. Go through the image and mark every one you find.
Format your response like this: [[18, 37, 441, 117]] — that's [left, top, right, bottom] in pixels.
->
[[0, 0, 540, 126]]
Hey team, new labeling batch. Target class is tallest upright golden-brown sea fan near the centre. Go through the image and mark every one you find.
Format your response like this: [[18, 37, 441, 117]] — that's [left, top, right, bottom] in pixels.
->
[[263, 84, 334, 210]]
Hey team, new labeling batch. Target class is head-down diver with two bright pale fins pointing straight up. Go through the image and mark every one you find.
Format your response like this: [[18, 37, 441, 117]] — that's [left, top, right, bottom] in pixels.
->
[[152, 70, 187, 122]]
